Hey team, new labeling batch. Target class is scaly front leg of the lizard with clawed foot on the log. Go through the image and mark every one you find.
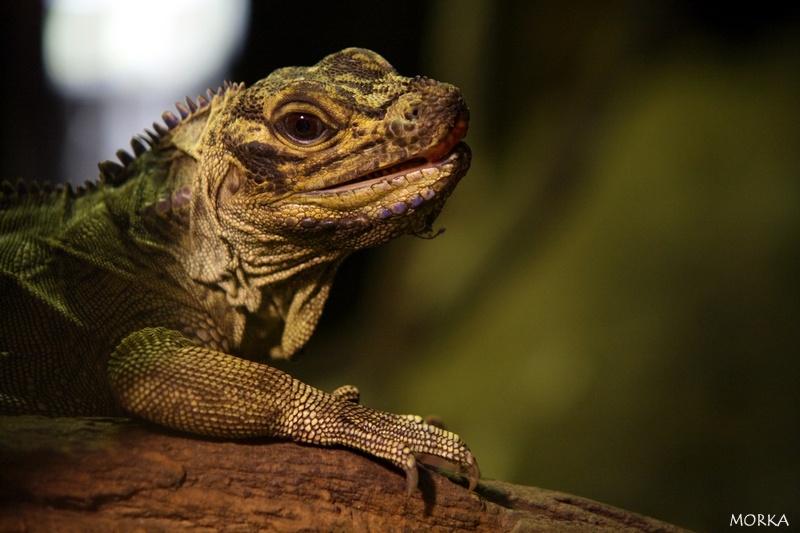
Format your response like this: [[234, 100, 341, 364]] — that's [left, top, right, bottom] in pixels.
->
[[109, 328, 480, 493]]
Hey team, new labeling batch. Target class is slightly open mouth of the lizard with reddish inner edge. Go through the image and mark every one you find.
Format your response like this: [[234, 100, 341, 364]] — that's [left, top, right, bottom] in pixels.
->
[[308, 113, 468, 193]]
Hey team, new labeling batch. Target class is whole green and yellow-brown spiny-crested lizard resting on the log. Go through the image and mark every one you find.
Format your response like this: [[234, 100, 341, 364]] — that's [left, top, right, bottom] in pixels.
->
[[0, 48, 480, 494]]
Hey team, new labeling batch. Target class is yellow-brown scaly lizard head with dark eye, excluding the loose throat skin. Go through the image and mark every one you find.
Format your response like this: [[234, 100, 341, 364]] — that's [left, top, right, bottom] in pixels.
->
[[201, 48, 470, 250]]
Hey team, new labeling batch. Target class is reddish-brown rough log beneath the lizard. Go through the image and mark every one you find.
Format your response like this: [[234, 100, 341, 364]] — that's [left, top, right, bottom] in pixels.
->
[[0, 416, 681, 532]]
